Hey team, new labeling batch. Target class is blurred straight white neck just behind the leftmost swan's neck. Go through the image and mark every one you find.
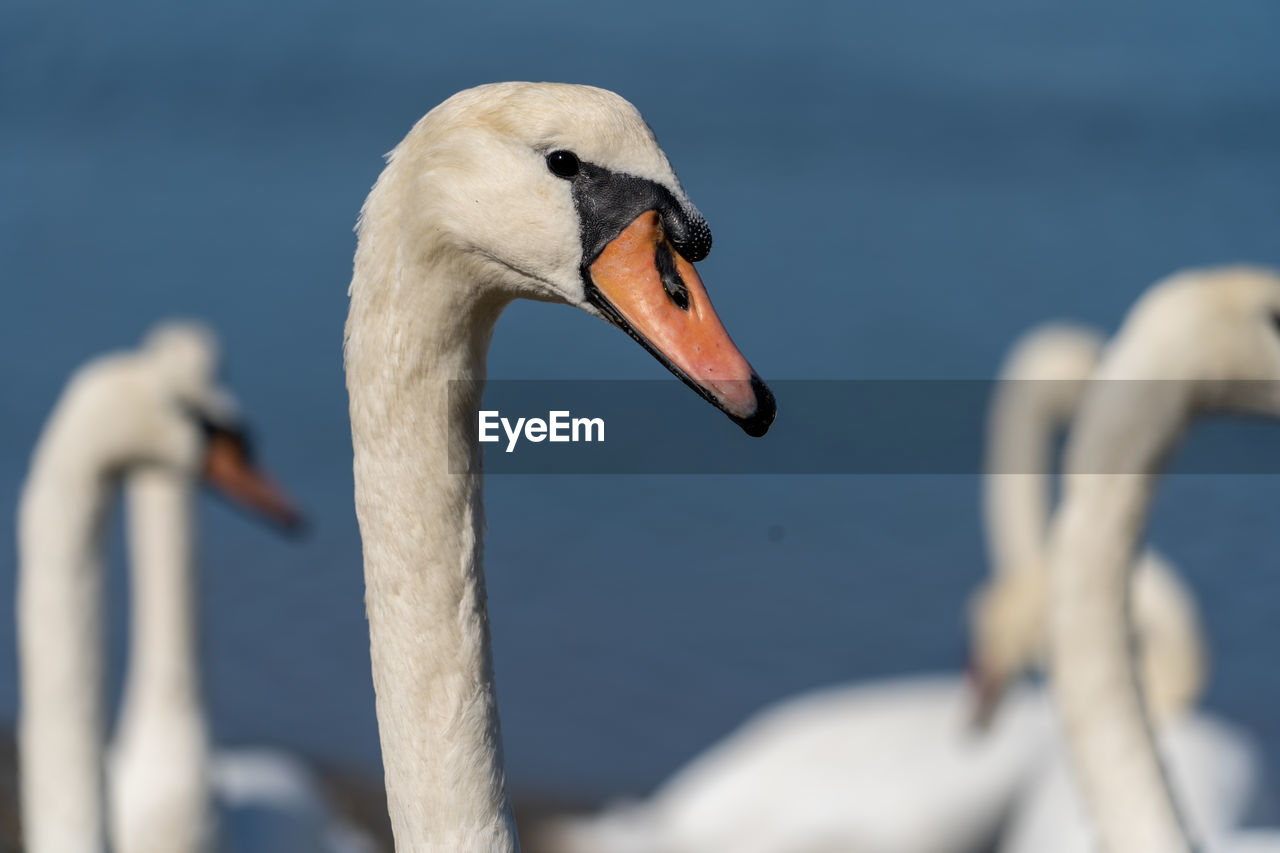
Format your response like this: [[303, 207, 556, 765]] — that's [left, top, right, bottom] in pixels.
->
[[110, 466, 214, 853]]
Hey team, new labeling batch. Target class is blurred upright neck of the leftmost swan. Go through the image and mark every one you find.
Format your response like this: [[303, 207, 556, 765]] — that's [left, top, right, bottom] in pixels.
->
[[17, 448, 110, 853]]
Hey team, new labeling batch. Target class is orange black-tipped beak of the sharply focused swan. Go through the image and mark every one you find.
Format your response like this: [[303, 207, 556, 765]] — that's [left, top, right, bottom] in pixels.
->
[[586, 210, 777, 435]]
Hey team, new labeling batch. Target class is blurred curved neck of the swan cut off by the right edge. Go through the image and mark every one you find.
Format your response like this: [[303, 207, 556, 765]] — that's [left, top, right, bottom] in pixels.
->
[[1051, 382, 1194, 853]]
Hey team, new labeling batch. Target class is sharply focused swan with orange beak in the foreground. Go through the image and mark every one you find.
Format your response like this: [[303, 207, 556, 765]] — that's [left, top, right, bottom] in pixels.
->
[[344, 83, 776, 853]]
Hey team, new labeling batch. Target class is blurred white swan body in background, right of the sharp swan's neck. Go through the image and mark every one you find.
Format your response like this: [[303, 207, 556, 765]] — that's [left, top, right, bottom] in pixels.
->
[[547, 676, 1052, 853]]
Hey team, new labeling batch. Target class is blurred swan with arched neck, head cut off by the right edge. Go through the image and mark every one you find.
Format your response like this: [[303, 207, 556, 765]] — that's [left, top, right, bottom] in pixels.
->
[[1050, 266, 1280, 853]]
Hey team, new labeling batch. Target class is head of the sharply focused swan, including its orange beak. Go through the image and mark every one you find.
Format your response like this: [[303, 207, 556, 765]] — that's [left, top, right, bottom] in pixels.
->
[[363, 83, 776, 435]]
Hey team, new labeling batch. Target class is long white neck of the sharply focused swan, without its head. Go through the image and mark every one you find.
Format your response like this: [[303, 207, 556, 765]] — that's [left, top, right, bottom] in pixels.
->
[[346, 190, 517, 853]]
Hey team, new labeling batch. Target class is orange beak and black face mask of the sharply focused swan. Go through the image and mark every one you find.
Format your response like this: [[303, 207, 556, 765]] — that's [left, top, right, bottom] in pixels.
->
[[564, 163, 777, 435]]
